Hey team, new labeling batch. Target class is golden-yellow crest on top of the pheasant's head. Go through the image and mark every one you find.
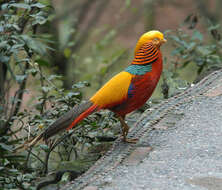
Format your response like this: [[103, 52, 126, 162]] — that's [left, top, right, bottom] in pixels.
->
[[135, 30, 166, 54]]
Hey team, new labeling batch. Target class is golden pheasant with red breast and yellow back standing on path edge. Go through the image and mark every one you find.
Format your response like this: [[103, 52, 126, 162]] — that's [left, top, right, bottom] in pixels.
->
[[35, 30, 167, 143]]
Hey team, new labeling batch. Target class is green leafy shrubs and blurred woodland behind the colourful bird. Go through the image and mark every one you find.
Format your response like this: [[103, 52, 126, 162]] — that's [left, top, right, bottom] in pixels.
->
[[0, 0, 222, 189]]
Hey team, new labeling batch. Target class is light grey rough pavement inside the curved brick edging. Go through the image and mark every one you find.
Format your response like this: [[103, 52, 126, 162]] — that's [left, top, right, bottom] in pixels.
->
[[97, 96, 222, 190]]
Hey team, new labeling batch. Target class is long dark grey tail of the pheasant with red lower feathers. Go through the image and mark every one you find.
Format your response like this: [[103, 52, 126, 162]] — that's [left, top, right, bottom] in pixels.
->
[[43, 101, 98, 140]]
